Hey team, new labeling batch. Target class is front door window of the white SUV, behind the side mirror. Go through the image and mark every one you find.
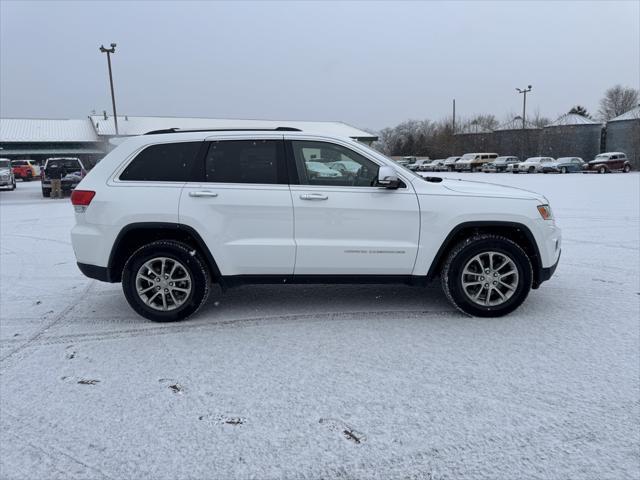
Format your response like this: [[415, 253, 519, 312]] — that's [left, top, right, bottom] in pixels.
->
[[291, 140, 378, 187]]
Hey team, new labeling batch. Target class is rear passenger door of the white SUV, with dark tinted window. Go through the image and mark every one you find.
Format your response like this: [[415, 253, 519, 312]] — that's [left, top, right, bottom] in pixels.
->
[[180, 134, 295, 276]]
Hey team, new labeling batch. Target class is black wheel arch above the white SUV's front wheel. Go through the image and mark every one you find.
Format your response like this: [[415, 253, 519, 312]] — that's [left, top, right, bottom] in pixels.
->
[[427, 221, 543, 289]]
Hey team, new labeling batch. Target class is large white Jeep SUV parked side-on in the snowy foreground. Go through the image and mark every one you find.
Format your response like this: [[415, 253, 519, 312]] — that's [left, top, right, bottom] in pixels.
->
[[71, 128, 561, 321]]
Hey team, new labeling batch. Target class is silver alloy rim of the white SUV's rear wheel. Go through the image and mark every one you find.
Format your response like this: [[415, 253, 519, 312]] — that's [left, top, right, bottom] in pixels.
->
[[136, 257, 192, 312]]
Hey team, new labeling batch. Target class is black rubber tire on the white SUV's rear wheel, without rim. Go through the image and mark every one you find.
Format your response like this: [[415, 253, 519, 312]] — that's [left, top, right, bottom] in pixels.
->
[[122, 240, 211, 322]]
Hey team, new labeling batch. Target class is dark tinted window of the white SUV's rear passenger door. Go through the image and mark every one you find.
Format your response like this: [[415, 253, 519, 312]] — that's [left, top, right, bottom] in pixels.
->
[[205, 140, 288, 184]]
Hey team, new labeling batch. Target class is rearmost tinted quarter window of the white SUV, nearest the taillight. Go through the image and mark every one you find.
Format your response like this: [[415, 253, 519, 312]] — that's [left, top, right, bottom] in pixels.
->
[[120, 142, 202, 182]]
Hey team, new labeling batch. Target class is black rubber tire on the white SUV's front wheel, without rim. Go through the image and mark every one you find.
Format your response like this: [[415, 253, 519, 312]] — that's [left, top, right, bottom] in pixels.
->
[[441, 234, 533, 317]]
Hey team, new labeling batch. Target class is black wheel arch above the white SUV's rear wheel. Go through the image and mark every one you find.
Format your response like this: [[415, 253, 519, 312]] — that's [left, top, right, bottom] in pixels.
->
[[107, 222, 221, 283]]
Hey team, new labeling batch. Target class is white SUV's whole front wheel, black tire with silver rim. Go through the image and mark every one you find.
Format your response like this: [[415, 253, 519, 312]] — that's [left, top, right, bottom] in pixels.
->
[[441, 234, 533, 317]]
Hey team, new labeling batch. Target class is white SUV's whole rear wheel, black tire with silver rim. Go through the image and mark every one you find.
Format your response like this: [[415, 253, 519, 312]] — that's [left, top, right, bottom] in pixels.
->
[[122, 240, 211, 322]]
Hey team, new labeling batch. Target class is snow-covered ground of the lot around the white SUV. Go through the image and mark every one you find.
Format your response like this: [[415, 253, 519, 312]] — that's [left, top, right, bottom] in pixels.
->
[[0, 173, 640, 480]]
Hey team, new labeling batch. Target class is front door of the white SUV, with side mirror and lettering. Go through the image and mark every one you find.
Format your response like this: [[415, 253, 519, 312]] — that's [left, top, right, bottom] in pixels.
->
[[288, 138, 420, 275]]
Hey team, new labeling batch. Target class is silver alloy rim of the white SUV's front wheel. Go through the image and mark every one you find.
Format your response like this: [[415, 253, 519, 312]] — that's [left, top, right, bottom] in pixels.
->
[[461, 251, 520, 307]]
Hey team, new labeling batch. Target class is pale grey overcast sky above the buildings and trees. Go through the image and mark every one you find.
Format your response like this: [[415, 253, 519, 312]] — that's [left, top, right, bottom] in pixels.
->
[[0, 0, 640, 129]]
